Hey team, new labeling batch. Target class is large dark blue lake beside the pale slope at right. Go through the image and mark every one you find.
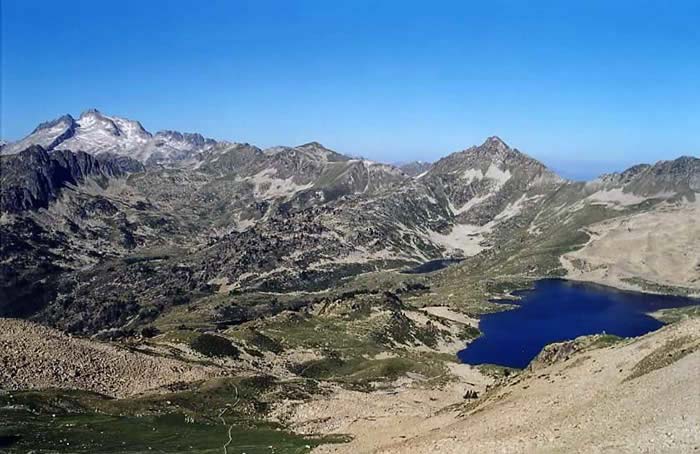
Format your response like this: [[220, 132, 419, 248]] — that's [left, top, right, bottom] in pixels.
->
[[458, 279, 700, 368]]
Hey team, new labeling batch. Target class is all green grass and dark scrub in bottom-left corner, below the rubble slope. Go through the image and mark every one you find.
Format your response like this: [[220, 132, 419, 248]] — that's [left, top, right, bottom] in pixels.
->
[[0, 376, 345, 453]]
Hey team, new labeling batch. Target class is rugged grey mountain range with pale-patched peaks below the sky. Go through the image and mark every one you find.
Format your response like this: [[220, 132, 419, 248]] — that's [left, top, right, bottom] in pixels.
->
[[0, 109, 700, 333]]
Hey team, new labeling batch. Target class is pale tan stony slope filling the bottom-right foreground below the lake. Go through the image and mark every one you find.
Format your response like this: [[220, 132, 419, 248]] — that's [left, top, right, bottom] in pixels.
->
[[304, 319, 700, 453]]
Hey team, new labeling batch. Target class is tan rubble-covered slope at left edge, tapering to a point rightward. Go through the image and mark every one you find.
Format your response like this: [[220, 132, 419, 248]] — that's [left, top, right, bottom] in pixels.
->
[[0, 319, 221, 397]]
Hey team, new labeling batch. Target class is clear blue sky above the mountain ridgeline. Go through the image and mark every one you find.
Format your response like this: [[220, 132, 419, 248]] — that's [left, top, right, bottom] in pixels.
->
[[0, 0, 700, 177]]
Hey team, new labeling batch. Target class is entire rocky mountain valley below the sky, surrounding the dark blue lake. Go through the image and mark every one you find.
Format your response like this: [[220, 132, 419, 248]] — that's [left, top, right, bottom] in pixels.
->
[[0, 109, 700, 453]]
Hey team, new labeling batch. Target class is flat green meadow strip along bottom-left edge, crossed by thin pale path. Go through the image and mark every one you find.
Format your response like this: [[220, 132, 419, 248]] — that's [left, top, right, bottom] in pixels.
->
[[0, 410, 333, 454]]
